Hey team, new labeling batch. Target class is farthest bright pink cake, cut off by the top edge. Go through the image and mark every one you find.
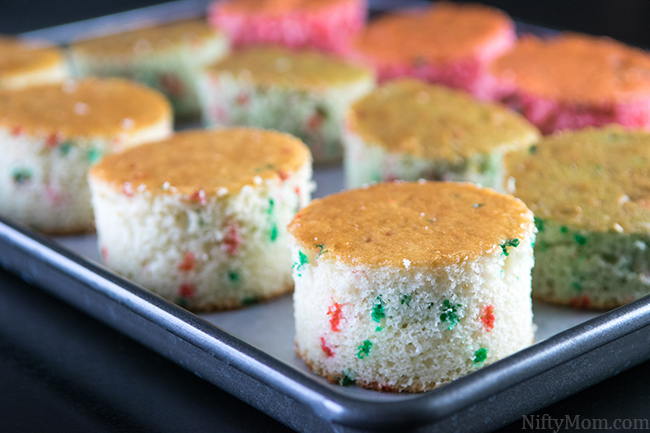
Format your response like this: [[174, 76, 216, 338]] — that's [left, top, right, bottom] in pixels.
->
[[208, 0, 367, 53]]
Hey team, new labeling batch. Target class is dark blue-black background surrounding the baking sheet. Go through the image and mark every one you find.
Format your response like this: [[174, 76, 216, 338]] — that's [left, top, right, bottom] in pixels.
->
[[0, 0, 650, 433]]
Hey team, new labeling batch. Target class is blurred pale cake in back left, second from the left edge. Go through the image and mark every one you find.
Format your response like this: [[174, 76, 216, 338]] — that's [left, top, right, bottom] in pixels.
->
[[70, 20, 229, 117]]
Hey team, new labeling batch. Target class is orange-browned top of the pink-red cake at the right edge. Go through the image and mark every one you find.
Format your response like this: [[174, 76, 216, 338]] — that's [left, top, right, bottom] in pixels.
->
[[491, 34, 650, 103]]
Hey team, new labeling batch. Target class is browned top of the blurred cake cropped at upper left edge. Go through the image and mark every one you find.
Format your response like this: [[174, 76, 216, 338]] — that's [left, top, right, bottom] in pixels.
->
[[0, 36, 63, 79]]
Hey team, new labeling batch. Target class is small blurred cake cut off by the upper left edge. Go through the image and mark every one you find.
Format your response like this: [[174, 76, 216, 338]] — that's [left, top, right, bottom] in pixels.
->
[[0, 36, 68, 90]]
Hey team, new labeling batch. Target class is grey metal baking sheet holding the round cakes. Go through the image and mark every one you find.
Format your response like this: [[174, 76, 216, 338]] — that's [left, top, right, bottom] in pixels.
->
[[0, 0, 650, 432]]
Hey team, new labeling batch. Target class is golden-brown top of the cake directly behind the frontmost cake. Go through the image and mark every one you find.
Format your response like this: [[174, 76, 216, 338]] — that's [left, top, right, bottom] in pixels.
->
[[349, 79, 539, 161]]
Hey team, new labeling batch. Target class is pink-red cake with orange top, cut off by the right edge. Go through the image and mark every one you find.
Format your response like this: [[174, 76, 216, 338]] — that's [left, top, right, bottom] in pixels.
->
[[490, 34, 650, 134]]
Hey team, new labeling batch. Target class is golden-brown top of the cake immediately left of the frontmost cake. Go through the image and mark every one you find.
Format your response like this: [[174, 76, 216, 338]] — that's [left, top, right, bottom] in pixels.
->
[[91, 128, 311, 196]]
